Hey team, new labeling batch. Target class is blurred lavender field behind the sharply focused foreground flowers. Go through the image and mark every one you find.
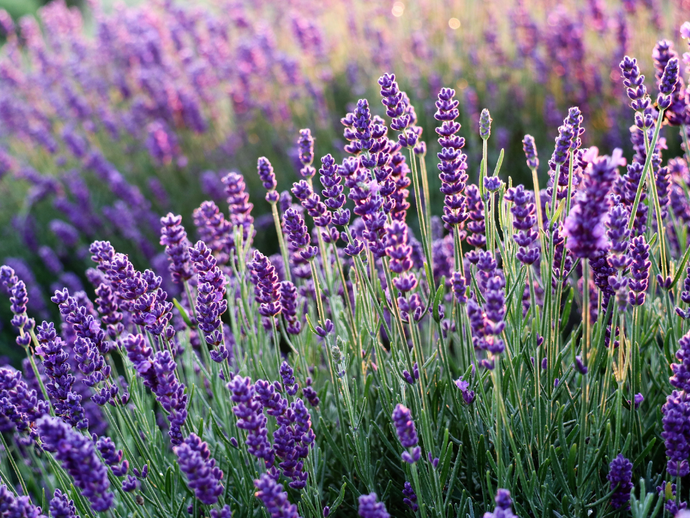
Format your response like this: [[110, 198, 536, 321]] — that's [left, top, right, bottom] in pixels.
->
[[0, 0, 690, 356]]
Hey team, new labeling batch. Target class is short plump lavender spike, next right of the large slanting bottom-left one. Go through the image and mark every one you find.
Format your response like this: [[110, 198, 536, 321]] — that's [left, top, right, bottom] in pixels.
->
[[174, 433, 223, 505]]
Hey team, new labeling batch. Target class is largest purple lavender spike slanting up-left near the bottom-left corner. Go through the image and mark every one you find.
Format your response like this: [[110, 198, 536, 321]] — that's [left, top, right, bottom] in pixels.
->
[[37, 416, 114, 512]]
